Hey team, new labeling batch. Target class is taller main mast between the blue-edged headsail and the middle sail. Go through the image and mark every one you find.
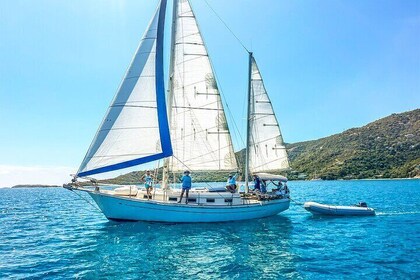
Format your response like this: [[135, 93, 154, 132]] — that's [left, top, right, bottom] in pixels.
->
[[162, 0, 178, 189]]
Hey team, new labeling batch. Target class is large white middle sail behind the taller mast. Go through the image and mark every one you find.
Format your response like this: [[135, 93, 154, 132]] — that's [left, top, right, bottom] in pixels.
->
[[168, 0, 237, 171]]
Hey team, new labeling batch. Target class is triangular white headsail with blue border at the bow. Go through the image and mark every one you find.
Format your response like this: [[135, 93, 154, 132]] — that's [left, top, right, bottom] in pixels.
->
[[77, 0, 172, 177]]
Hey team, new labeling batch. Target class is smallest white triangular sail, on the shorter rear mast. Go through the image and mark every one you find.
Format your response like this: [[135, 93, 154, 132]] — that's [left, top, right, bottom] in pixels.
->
[[249, 57, 289, 173]]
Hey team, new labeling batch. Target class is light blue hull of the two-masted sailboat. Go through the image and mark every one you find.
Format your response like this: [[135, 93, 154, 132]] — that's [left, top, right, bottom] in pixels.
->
[[88, 192, 290, 223]]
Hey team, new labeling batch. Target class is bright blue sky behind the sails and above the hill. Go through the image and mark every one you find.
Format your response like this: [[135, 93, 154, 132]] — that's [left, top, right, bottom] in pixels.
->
[[0, 0, 420, 187]]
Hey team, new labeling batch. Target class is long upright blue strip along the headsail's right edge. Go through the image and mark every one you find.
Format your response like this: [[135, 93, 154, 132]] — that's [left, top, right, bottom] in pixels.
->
[[155, 0, 173, 156]]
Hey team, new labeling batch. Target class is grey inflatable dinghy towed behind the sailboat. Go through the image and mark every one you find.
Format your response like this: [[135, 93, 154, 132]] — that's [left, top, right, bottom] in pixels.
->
[[303, 202, 375, 216]]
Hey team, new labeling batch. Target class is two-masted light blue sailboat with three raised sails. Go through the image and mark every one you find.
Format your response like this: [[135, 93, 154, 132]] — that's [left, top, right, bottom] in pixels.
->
[[64, 0, 290, 223]]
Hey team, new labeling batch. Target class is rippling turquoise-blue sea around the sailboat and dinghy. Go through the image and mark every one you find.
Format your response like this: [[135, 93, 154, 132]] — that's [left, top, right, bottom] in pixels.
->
[[0, 180, 420, 280]]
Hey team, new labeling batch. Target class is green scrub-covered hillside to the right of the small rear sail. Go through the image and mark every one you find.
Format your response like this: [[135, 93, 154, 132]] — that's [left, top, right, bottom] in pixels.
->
[[287, 109, 420, 180]]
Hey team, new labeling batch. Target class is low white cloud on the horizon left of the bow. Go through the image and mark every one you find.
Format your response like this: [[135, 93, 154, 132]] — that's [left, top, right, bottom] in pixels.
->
[[0, 165, 75, 188]]
